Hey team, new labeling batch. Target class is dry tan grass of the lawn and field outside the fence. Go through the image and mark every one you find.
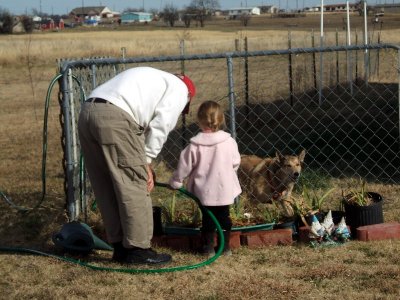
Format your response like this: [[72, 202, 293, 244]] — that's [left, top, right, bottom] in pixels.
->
[[0, 16, 400, 299]]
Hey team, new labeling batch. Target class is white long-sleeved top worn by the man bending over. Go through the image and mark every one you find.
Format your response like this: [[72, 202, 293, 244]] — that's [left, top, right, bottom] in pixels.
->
[[89, 67, 189, 163]]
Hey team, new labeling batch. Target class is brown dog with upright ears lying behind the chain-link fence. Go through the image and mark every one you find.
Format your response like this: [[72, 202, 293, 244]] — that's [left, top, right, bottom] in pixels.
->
[[238, 150, 306, 217]]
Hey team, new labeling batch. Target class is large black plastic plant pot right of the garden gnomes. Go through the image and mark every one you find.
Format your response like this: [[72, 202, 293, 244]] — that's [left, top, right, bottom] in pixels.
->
[[343, 192, 383, 236]]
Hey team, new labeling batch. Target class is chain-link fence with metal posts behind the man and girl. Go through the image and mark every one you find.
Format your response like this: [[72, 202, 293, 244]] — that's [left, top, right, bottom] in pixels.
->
[[59, 44, 400, 220]]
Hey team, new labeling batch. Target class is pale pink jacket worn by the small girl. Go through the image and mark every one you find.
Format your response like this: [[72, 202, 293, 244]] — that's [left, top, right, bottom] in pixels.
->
[[169, 130, 242, 206]]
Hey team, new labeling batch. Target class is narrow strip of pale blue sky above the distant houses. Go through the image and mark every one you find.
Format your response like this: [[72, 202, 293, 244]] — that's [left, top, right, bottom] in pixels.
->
[[0, 0, 388, 15]]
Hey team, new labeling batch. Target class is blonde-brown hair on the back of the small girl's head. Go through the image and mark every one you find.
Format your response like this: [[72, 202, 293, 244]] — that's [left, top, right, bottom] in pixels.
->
[[197, 101, 225, 131]]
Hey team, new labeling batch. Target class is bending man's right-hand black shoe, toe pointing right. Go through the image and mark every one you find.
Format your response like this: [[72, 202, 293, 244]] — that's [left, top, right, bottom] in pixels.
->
[[124, 248, 172, 265]]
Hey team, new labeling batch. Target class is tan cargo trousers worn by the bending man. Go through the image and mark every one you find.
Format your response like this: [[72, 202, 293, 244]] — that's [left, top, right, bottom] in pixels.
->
[[78, 102, 153, 248]]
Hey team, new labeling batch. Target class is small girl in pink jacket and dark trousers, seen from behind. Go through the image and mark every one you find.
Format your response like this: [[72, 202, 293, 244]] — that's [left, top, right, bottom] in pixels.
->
[[169, 101, 242, 256]]
